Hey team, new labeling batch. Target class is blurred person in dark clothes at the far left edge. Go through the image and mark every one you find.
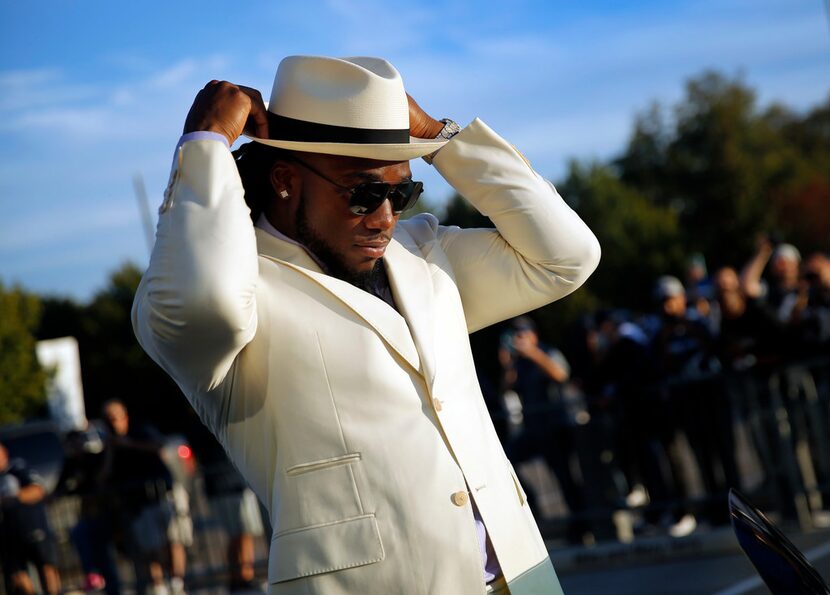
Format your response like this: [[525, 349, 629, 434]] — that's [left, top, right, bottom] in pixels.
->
[[0, 444, 61, 595]]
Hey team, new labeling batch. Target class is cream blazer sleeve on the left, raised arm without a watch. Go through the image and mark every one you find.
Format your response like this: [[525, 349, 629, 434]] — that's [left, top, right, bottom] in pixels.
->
[[132, 140, 258, 394]]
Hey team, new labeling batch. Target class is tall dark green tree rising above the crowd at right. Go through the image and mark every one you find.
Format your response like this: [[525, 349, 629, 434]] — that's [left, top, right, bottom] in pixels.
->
[[615, 72, 830, 265]]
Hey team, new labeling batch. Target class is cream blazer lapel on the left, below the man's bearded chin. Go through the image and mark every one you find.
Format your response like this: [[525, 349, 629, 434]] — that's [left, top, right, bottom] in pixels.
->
[[256, 229, 422, 372]]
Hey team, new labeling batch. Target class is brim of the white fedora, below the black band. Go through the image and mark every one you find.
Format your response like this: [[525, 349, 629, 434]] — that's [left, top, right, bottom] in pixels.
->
[[245, 134, 447, 161]]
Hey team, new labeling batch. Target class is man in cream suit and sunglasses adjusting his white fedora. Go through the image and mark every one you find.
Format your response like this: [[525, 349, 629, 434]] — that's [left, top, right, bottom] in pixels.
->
[[133, 56, 599, 595]]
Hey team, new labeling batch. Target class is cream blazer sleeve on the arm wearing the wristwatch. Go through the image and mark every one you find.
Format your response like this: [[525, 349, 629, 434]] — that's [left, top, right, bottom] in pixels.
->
[[433, 119, 600, 332]]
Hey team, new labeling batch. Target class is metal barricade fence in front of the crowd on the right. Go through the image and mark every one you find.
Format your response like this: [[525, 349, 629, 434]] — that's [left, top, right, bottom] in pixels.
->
[[506, 355, 830, 539]]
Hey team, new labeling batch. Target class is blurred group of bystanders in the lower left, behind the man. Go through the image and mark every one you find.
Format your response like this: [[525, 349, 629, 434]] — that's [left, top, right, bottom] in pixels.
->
[[0, 399, 264, 595]]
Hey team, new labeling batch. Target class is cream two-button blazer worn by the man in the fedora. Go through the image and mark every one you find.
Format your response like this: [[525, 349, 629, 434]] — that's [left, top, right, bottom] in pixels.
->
[[133, 120, 600, 595]]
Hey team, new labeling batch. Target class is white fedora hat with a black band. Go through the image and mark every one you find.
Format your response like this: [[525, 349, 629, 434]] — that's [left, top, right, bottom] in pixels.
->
[[245, 56, 446, 161]]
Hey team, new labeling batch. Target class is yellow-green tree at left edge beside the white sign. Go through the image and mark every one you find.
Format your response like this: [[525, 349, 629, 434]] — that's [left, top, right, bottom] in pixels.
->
[[0, 283, 46, 424]]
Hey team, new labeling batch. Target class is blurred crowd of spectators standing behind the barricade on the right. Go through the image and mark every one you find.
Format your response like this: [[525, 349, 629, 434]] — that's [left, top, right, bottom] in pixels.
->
[[498, 237, 830, 543]]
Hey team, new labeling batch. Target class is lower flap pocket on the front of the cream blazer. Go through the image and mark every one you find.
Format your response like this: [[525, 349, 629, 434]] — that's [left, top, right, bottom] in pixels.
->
[[268, 514, 385, 583]]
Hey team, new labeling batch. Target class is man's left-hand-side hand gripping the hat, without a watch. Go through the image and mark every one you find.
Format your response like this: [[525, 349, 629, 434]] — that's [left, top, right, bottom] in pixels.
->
[[184, 81, 270, 144]]
